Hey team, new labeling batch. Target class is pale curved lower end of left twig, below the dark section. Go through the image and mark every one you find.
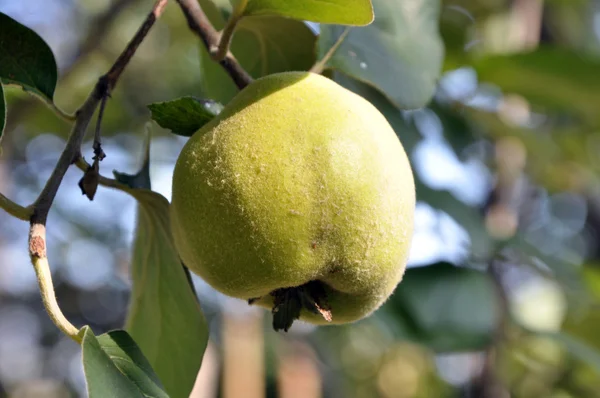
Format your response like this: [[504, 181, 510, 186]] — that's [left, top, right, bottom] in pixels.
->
[[29, 224, 81, 344]]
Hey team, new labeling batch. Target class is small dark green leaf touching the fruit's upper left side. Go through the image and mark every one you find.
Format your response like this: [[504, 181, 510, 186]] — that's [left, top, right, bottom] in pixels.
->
[[148, 97, 223, 137]]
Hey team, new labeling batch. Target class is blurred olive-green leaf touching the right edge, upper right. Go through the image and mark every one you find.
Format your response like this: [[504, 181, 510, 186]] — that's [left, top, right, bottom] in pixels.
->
[[473, 47, 600, 125]]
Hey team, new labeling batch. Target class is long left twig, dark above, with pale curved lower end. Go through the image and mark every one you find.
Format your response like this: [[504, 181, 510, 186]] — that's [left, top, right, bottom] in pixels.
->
[[29, 0, 167, 342]]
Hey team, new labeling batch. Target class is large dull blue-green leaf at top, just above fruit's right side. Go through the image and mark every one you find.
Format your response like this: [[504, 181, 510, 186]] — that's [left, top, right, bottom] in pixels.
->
[[318, 0, 444, 109]]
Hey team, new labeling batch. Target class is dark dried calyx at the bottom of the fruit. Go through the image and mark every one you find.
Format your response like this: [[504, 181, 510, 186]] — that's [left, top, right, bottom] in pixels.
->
[[270, 281, 332, 332]]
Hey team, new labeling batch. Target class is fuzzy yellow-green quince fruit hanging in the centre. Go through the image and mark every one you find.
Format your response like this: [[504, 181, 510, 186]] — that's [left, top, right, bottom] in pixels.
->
[[171, 72, 415, 324]]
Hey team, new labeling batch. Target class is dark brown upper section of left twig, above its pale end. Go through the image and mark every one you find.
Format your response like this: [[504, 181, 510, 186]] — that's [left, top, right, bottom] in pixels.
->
[[31, 0, 167, 228]]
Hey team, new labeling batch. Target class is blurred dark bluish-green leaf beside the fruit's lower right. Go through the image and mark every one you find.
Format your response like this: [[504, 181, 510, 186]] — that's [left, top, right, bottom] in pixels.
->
[[386, 263, 501, 352]]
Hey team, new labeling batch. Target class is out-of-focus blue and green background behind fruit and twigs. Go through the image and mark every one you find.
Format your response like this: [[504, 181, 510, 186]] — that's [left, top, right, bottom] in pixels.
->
[[0, 0, 600, 398]]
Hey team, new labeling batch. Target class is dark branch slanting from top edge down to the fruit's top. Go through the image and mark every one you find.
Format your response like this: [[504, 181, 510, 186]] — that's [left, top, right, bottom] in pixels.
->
[[177, 0, 252, 90]]
